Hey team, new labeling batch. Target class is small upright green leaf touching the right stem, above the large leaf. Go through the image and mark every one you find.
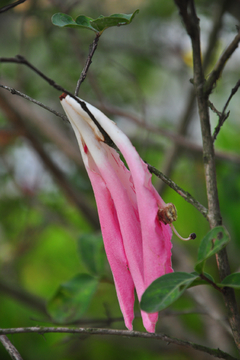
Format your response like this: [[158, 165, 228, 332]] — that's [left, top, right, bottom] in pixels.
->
[[195, 226, 230, 273]]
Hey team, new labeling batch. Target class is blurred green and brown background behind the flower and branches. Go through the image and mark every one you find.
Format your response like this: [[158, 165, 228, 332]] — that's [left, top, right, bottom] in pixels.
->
[[0, 0, 240, 360]]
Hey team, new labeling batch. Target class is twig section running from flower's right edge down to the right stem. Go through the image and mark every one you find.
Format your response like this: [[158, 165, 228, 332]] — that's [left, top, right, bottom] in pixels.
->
[[147, 164, 208, 218]]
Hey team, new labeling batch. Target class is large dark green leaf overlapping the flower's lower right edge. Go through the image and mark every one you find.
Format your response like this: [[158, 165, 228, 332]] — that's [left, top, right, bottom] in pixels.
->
[[140, 272, 199, 313]]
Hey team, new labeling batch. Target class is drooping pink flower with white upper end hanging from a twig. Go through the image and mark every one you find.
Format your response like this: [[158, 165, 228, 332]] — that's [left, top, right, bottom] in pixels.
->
[[60, 94, 173, 332]]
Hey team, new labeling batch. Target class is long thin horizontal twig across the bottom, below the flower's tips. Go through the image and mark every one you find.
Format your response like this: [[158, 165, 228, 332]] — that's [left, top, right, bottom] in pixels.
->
[[0, 326, 237, 360]]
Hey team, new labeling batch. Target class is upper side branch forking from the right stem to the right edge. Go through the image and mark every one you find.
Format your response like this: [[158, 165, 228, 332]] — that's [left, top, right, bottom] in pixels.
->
[[204, 30, 240, 95]]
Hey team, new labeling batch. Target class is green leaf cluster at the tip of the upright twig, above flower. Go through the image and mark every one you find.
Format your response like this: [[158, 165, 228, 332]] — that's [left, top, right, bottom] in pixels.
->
[[52, 10, 139, 33]]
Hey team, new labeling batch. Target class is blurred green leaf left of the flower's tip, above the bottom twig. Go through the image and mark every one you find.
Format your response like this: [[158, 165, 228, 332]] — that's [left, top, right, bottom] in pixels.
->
[[47, 274, 98, 324]]
